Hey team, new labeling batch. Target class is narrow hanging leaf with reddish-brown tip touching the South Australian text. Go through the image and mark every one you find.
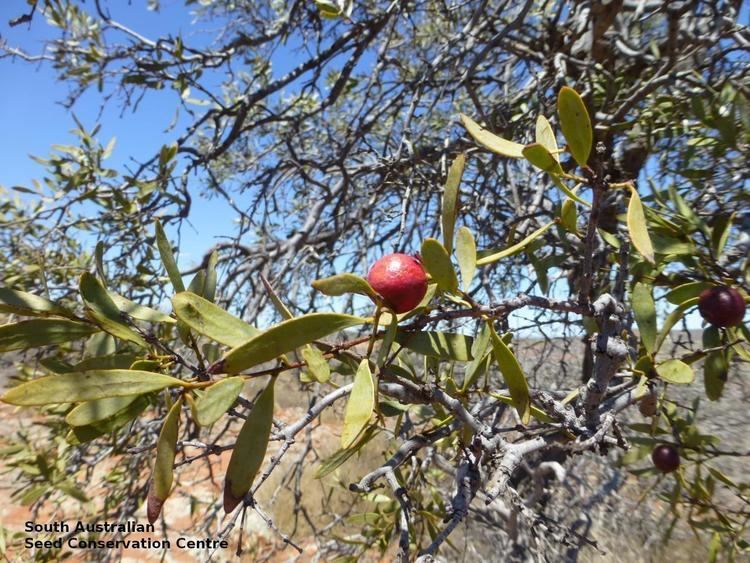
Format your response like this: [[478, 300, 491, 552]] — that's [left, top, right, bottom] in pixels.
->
[[146, 397, 182, 524]]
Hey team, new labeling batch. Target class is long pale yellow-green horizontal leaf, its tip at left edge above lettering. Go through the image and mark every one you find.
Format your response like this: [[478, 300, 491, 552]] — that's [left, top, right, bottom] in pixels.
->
[[0, 369, 184, 406]]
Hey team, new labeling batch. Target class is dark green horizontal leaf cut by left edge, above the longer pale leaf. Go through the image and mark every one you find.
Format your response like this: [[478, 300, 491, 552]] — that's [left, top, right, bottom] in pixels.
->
[[0, 319, 100, 352]]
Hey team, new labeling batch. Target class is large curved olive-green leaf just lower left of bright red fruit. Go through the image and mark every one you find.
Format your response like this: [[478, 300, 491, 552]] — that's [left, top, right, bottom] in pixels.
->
[[212, 313, 367, 373]]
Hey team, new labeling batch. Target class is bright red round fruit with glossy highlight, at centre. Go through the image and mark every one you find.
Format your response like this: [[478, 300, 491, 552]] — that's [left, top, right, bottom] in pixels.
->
[[367, 254, 427, 313]]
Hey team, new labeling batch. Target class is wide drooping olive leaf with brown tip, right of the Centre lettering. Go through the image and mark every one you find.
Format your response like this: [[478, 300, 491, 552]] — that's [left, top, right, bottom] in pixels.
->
[[224, 379, 276, 513]]
